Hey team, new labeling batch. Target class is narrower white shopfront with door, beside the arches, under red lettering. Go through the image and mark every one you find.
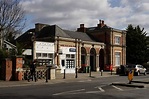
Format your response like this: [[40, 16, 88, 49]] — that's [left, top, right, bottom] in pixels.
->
[[60, 47, 76, 73]]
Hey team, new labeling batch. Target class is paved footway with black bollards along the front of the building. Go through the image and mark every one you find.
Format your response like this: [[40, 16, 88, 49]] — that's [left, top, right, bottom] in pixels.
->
[[0, 71, 116, 87]]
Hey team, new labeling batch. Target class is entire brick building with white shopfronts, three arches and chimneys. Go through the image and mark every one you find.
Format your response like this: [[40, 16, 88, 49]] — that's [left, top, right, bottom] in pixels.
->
[[17, 20, 126, 73]]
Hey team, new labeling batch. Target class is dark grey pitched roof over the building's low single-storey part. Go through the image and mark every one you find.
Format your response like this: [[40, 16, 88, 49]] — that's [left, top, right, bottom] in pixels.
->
[[16, 25, 98, 42]]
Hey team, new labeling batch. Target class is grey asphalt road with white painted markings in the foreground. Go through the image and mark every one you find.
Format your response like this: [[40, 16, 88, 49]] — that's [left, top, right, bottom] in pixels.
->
[[0, 75, 149, 99]]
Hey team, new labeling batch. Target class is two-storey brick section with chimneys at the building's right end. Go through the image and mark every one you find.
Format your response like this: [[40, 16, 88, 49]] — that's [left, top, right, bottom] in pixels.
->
[[77, 20, 126, 69]]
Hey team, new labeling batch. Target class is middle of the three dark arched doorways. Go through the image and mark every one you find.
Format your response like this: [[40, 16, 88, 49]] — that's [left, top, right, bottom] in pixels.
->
[[90, 48, 96, 71]]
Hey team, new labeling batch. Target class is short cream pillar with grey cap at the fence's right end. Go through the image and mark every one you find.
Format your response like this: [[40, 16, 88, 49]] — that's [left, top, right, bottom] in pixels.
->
[[46, 64, 57, 79]]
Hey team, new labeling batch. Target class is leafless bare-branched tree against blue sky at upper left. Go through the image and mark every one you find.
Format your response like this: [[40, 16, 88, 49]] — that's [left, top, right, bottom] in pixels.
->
[[0, 0, 26, 48]]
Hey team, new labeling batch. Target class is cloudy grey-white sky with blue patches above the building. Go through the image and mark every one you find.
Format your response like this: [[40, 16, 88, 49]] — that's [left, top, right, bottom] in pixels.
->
[[21, 0, 149, 33]]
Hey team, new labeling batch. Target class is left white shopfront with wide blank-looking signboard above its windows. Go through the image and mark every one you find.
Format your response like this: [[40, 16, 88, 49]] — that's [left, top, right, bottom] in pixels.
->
[[33, 41, 54, 66]]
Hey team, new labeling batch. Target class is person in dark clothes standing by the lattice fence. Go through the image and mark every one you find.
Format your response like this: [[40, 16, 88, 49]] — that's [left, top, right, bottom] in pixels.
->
[[28, 60, 37, 82]]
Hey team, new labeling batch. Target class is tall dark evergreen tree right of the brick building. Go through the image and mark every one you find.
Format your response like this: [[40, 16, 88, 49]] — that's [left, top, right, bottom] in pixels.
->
[[126, 24, 147, 64]]
